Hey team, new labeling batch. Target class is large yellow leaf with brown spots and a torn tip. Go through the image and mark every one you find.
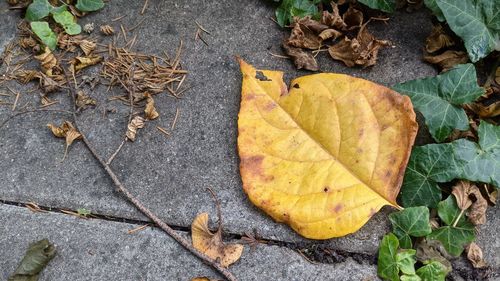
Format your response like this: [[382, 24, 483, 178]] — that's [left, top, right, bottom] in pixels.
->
[[238, 60, 418, 239]]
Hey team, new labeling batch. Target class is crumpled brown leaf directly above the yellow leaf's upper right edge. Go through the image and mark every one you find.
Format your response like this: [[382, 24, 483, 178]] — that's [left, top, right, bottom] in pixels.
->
[[328, 24, 389, 67]]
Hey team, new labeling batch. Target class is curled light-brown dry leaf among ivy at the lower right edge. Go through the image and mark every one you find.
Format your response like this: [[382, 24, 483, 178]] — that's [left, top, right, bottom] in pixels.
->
[[451, 181, 488, 225]]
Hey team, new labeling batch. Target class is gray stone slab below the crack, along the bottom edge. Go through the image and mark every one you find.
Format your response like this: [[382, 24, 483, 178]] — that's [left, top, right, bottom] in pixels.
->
[[0, 204, 379, 281]]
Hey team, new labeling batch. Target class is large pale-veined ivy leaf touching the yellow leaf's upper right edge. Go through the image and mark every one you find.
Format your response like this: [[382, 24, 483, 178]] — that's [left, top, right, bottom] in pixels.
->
[[393, 63, 484, 142]]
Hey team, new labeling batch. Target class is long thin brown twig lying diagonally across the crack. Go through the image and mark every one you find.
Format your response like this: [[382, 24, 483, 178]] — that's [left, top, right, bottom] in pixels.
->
[[63, 69, 237, 281]]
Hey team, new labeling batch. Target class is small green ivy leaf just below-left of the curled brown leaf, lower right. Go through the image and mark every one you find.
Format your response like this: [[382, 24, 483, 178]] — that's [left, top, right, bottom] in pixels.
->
[[428, 222, 475, 256]]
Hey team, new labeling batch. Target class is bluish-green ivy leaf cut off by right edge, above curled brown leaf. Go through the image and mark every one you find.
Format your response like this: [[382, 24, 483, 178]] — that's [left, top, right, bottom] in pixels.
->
[[453, 121, 500, 188]]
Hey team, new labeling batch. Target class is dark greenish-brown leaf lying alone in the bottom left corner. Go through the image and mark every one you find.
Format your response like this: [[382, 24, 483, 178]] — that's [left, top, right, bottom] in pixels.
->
[[8, 239, 56, 281]]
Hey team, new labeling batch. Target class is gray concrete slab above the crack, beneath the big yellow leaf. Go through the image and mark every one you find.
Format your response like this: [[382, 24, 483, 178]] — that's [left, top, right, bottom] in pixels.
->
[[0, 0, 496, 270]]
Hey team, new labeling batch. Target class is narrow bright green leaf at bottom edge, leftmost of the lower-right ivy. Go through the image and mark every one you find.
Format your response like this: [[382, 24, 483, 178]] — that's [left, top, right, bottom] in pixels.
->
[[377, 233, 399, 281]]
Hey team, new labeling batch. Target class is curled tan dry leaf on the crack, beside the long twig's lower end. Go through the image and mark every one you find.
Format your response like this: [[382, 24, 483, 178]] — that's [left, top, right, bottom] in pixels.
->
[[191, 213, 243, 267]]
